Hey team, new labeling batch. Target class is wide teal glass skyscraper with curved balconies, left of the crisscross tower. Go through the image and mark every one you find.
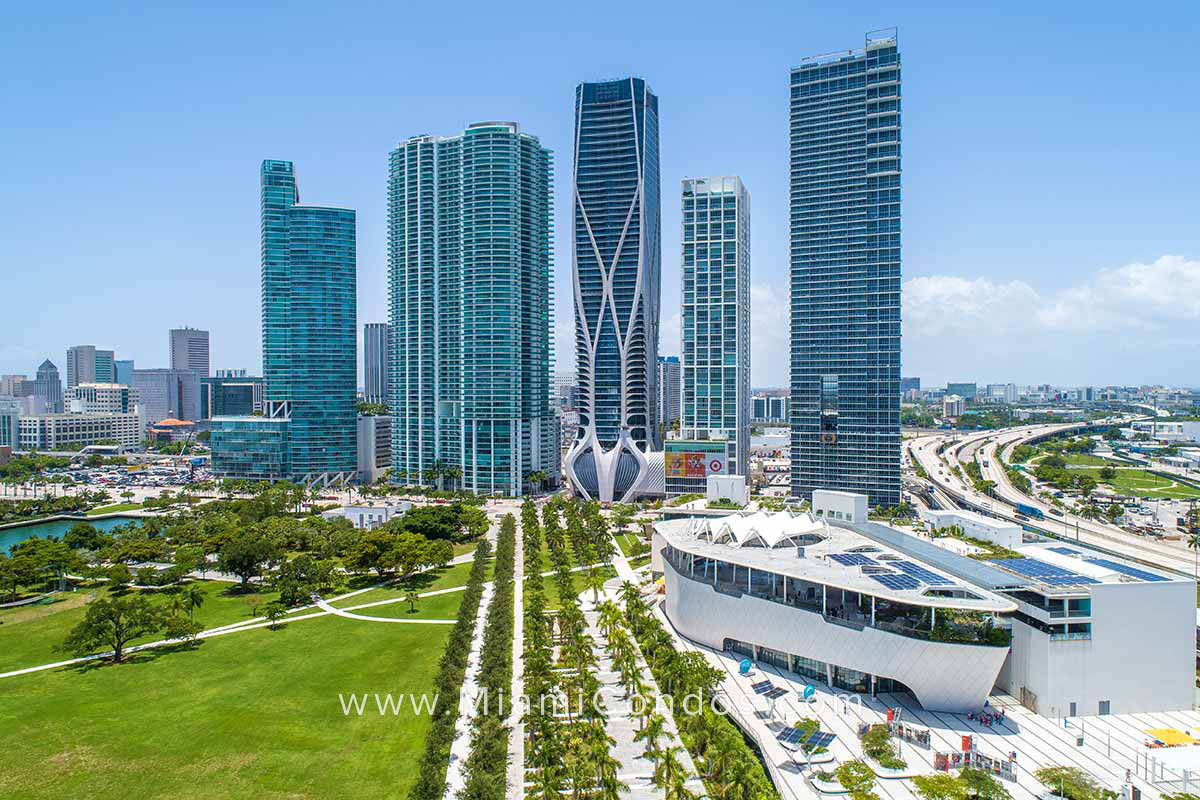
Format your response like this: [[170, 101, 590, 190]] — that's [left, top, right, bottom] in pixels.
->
[[388, 122, 560, 494]]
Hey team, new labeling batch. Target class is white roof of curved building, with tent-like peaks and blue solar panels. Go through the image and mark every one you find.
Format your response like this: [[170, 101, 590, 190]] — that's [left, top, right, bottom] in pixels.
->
[[654, 512, 1020, 613]]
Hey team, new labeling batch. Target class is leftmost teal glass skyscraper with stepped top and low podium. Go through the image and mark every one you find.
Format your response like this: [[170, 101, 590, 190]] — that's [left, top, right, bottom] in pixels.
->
[[212, 155, 358, 485]]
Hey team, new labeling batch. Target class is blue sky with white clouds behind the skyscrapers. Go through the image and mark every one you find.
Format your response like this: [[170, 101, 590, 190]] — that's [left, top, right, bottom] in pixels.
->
[[0, 1, 1200, 385]]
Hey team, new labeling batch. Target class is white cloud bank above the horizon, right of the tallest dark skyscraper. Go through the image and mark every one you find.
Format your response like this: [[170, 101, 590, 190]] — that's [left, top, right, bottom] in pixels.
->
[[902, 255, 1200, 385]]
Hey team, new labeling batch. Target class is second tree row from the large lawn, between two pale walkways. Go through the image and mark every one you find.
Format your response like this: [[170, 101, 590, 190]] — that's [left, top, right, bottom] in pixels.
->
[[458, 515, 517, 800]]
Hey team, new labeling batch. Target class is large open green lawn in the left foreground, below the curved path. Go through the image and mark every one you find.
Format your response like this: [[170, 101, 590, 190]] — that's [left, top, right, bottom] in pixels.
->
[[0, 616, 450, 800]]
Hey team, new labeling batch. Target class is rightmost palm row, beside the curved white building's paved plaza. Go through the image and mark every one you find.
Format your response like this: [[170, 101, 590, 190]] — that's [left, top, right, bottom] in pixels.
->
[[620, 582, 779, 800]]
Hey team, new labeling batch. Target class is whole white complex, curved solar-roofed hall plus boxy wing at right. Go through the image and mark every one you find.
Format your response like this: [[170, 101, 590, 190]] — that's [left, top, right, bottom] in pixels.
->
[[652, 509, 1195, 716]]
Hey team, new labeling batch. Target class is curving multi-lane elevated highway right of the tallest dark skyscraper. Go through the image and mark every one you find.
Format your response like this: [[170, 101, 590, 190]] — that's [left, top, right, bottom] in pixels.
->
[[906, 423, 1195, 575]]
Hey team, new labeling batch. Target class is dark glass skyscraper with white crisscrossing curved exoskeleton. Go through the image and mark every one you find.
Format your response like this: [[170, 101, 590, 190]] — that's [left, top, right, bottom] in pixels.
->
[[566, 78, 662, 501]]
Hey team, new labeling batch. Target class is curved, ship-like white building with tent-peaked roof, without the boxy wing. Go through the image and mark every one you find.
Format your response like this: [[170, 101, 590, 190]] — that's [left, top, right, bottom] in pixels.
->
[[652, 512, 1016, 711]]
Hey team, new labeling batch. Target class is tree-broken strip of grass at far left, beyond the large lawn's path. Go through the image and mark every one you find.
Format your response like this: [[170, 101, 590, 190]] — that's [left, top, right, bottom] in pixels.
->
[[0, 581, 278, 676]]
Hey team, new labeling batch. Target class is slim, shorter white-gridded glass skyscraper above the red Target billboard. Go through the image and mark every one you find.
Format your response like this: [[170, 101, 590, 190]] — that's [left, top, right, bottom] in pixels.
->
[[679, 176, 750, 475]]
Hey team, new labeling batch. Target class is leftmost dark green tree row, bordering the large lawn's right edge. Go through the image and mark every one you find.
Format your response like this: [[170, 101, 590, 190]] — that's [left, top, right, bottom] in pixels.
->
[[408, 539, 492, 800]]
